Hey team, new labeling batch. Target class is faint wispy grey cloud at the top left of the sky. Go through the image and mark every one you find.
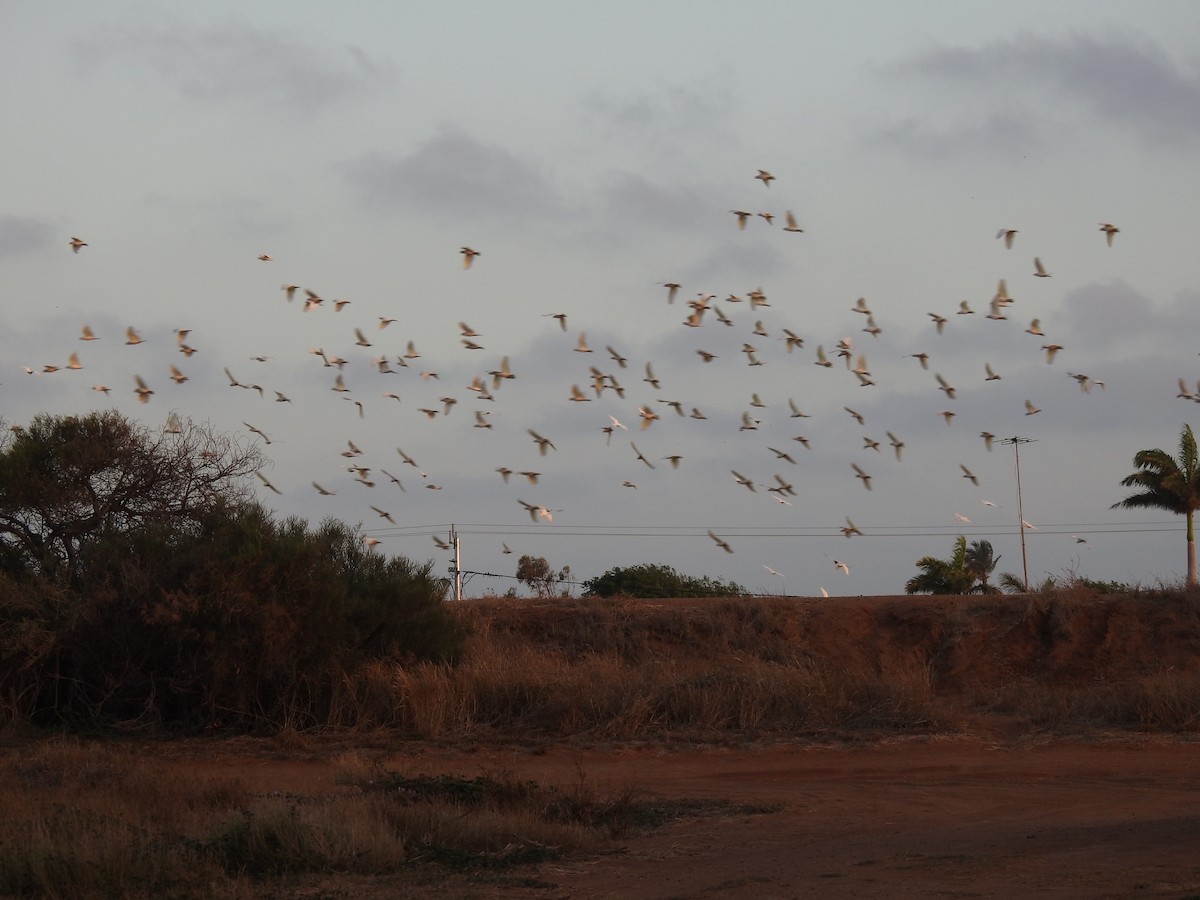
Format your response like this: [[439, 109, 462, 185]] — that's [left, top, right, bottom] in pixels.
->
[[76, 19, 392, 112]]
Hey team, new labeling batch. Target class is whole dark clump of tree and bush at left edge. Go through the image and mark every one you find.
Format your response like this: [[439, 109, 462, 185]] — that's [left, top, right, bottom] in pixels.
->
[[0, 413, 462, 727]]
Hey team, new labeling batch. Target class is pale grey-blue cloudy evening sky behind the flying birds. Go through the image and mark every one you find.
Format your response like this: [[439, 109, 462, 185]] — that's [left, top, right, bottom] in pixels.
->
[[0, 0, 1200, 596]]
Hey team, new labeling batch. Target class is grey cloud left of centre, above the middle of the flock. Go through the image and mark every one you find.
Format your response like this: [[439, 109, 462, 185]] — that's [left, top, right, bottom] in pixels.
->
[[338, 130, 562, 217]]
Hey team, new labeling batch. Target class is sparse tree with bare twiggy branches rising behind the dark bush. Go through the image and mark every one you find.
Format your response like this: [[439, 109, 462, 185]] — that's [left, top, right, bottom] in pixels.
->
[[0, 410, 263, 583]]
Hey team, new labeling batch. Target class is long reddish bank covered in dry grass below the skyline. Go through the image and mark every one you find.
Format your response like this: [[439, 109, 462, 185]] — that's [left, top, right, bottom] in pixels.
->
[[309, 584, 1200, 740]]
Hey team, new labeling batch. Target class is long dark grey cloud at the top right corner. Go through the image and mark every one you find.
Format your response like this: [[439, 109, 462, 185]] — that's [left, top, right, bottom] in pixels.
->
[[881, 34, 1200, 145]]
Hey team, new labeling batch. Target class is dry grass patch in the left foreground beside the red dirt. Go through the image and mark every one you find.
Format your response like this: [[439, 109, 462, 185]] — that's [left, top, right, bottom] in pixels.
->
[[0, 739, 667, 898]]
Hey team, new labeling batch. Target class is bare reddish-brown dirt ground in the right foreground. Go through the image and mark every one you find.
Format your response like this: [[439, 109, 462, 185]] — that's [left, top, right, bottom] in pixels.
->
[[175, 739, 1200, 900]]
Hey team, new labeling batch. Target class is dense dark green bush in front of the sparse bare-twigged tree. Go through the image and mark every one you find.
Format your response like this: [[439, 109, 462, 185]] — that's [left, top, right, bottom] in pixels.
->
[[0, 415, 462, 728]]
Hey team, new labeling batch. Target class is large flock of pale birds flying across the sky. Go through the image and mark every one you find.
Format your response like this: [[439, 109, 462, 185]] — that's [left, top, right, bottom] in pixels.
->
[[13, 169, 1152, 593]]
